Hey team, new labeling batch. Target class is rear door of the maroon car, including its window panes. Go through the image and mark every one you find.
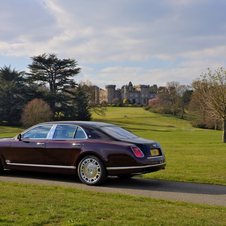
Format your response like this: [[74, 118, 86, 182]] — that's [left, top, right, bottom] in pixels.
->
[[46, 124, 87, 169]]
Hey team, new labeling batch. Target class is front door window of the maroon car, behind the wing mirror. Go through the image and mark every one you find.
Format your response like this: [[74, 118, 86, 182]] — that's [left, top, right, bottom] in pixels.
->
[[22, 125, 52, 139]]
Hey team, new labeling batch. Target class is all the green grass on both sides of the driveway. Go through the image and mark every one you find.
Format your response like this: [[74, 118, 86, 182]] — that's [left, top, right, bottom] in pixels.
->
[[0, 107, 226, 226]]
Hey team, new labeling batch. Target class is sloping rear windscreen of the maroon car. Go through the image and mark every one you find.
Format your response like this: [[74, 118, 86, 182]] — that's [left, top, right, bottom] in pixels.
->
[[101, 126, 137, 139]]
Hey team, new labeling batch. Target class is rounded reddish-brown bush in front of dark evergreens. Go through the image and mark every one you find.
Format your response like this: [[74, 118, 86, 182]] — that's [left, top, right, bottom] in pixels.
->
[[21, 98, 53, 126]]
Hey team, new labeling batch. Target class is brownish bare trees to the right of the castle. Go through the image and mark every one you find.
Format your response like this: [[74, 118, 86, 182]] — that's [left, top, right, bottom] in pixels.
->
[[146, 68, 226, 143]]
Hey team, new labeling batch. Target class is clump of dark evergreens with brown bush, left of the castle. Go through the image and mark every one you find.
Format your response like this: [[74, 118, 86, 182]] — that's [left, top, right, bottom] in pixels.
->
[[0, 54, 91, 125]]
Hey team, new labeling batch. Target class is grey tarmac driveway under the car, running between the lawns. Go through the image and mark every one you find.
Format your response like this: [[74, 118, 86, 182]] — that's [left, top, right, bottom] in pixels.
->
[[0, 170, 226, 195]]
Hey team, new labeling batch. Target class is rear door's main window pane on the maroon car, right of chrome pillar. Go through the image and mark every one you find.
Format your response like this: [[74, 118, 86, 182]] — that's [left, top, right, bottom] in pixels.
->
[[53, 125, 76, 139]]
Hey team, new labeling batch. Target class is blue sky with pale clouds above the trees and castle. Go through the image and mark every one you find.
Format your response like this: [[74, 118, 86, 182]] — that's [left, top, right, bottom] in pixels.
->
[[0, 0, 226, 89]]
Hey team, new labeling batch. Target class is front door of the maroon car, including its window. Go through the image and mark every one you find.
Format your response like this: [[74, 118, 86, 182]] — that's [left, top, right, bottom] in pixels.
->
[[5, 124, 52, 168]]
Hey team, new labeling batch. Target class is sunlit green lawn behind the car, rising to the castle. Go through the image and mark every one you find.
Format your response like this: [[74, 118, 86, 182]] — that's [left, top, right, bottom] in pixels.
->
[[93, 107, 226, 185]]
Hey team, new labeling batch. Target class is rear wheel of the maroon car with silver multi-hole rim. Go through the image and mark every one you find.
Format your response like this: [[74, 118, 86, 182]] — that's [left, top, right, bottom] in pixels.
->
[[78, 155, 107, 185]]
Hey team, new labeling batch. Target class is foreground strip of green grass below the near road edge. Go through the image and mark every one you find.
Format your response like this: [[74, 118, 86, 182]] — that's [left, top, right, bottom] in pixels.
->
[[0, 182, 226, 226]]
